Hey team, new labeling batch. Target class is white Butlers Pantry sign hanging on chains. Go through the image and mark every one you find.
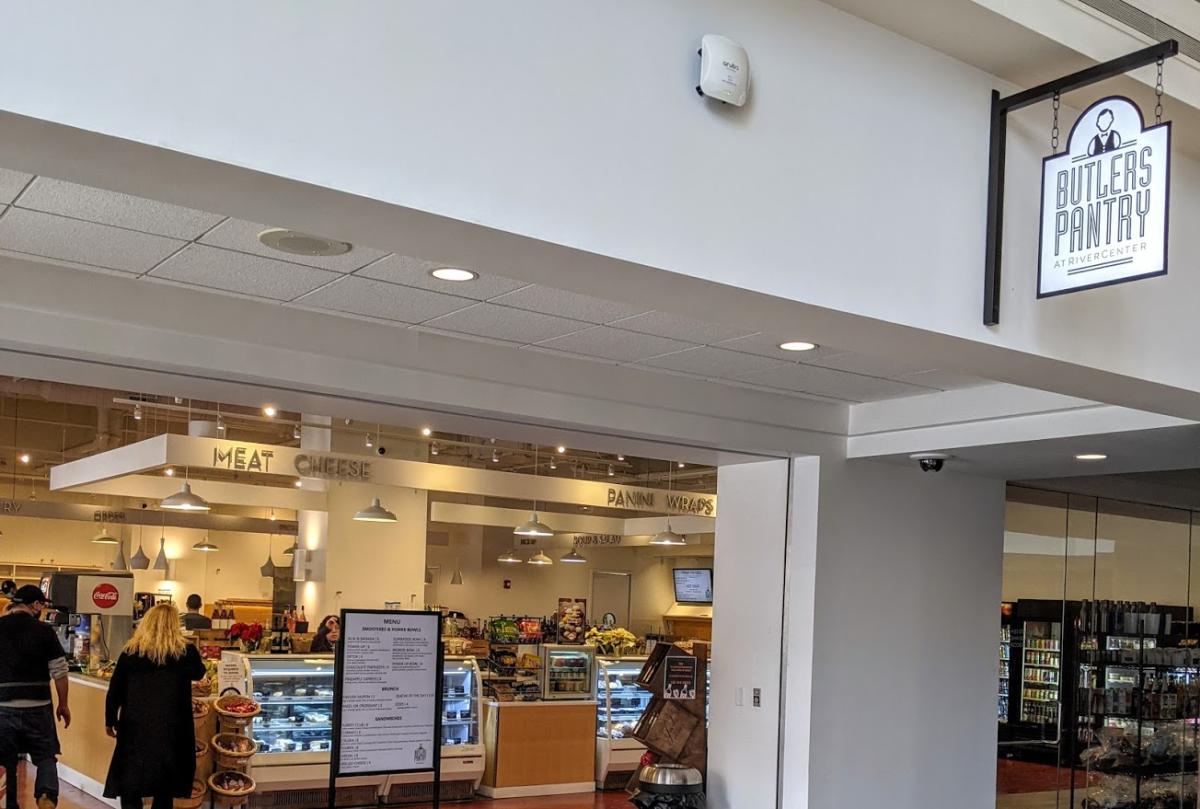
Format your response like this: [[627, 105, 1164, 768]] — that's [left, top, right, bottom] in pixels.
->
[[1038, 96, 1171, 298]]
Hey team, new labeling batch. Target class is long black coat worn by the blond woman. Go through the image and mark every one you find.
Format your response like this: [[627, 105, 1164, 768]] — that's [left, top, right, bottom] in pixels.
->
[[104, 646, 204, 798]]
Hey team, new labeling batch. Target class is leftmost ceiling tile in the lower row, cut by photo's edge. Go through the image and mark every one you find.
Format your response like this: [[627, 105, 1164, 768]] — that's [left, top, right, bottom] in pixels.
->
[[0, 208, 186, 272]]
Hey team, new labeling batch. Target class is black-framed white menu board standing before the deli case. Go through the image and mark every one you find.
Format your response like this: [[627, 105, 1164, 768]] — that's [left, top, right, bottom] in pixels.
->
[[330, 610, 443, 784]]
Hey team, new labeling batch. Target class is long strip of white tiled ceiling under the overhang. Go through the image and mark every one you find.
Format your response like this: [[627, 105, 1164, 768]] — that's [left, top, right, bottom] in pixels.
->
[[0, 169, 984, 402]]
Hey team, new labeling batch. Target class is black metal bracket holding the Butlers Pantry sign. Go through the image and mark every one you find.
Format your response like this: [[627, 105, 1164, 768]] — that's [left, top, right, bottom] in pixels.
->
[[983, 40, 1180, 325]]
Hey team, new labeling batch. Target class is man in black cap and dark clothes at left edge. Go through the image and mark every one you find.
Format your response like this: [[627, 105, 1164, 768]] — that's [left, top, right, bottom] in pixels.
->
[[0, 585, 71, 809]]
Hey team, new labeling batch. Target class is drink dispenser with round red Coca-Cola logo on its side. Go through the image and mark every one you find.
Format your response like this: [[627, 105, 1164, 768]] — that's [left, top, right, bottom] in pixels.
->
[[42, 571, 134, 667]]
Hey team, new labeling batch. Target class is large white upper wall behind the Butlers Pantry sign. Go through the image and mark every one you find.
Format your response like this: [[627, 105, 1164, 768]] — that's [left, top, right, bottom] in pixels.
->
[[7, 0, 1200, 403]]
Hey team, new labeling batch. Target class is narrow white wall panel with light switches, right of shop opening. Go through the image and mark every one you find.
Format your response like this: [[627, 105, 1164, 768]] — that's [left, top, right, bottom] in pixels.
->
[[707, 461, 792, 809]]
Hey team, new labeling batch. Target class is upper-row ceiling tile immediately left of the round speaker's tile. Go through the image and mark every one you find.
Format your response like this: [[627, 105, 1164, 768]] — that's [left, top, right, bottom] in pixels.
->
[[19, 176, 224, 241]]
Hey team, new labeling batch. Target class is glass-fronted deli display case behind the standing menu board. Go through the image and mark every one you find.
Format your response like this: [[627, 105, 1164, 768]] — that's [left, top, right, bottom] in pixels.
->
[[218, 651, 484, 805]]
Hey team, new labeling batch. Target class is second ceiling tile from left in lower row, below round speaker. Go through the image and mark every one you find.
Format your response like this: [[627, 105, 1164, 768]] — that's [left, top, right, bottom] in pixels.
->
[[150, 243, 338, 300]]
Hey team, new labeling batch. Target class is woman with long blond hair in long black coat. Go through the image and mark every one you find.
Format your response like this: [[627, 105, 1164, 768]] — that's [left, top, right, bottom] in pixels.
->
[[104, 604, 204, 809]]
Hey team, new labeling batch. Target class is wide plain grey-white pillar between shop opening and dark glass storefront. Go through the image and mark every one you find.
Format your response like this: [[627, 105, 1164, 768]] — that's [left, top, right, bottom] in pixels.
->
[[782, 457, 1004, 809]]
